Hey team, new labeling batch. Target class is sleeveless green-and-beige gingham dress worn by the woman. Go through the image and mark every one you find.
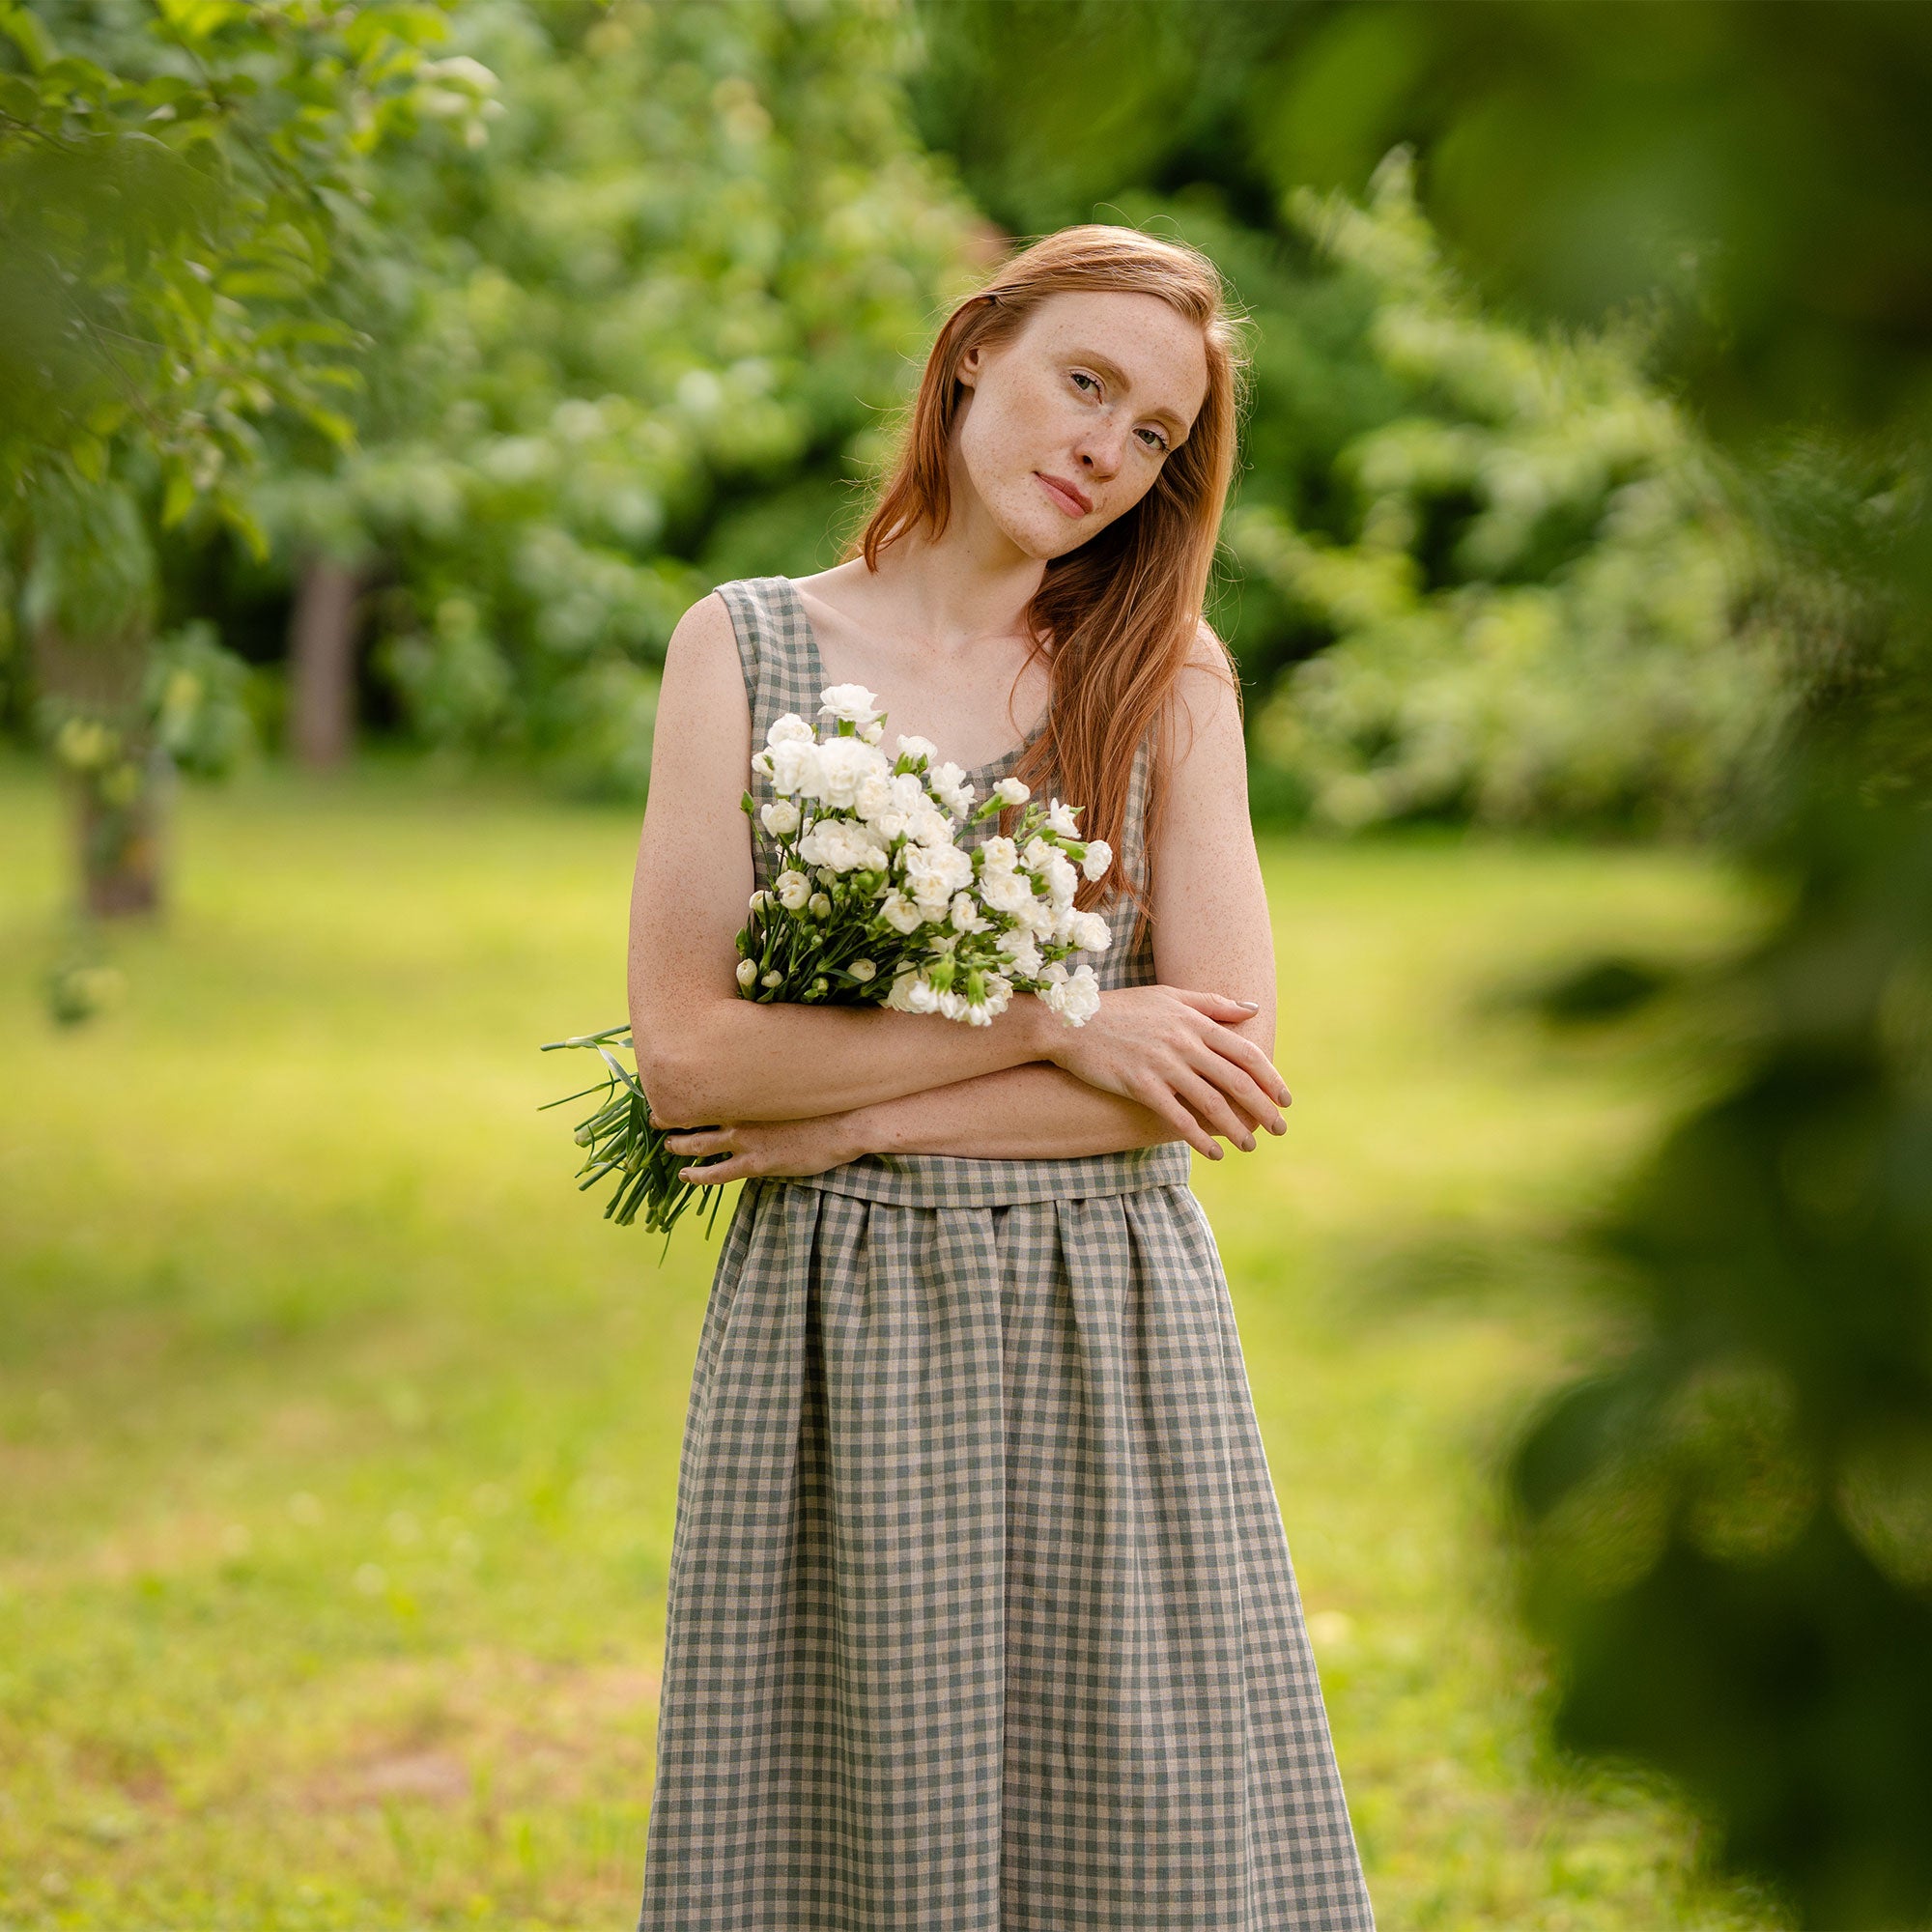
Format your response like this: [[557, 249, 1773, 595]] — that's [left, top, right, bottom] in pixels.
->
[[638, 578, 1374, 1932]]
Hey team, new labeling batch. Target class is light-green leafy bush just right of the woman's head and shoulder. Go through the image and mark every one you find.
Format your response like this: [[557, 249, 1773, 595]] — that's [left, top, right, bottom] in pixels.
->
[[1229, 149, 1787, 831]]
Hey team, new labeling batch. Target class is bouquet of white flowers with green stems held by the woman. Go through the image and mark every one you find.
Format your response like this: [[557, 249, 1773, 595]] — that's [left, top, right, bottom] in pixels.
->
[[543, 684, 1113, 1235]]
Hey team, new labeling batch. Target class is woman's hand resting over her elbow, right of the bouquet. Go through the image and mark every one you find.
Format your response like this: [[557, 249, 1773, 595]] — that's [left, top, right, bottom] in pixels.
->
[[1045, 985, 1293, 1161]]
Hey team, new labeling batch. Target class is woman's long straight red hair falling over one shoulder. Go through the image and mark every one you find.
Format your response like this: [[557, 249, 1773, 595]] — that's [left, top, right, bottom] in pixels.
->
[[840, 222, 1248, 937]]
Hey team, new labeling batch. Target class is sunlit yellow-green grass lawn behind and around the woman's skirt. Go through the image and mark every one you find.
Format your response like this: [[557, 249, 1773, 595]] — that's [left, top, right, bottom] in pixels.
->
[[0, 763, 1774, 1932]]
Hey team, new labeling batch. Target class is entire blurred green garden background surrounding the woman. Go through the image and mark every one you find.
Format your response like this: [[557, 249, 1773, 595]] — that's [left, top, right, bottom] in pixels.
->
[[0, 0, 1932, 1932]]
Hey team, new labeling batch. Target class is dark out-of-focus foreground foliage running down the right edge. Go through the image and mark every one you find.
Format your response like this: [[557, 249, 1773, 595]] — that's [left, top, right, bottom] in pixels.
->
[[1283, 0, 1932, 1932]]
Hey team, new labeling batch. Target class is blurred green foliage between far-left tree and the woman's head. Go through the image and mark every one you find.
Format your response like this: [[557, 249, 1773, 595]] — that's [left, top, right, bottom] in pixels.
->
[[261, 0, 972, 796]]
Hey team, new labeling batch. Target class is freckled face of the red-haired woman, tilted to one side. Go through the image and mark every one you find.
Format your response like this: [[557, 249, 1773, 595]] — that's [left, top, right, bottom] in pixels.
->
[[954, 290, 1208, 558]]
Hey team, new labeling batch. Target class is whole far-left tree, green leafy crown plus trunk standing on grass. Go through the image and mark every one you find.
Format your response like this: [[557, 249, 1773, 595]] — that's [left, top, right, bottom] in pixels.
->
[[0, 0, 487, 914]]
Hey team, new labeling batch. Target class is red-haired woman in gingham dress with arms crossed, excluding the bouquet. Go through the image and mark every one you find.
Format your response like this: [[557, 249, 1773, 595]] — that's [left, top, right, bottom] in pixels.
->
[[630, 226, 1372, 1932]]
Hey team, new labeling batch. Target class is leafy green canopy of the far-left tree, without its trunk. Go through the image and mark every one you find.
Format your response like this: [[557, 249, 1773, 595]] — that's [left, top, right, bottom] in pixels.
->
[[0, 0, 481, 529]]
